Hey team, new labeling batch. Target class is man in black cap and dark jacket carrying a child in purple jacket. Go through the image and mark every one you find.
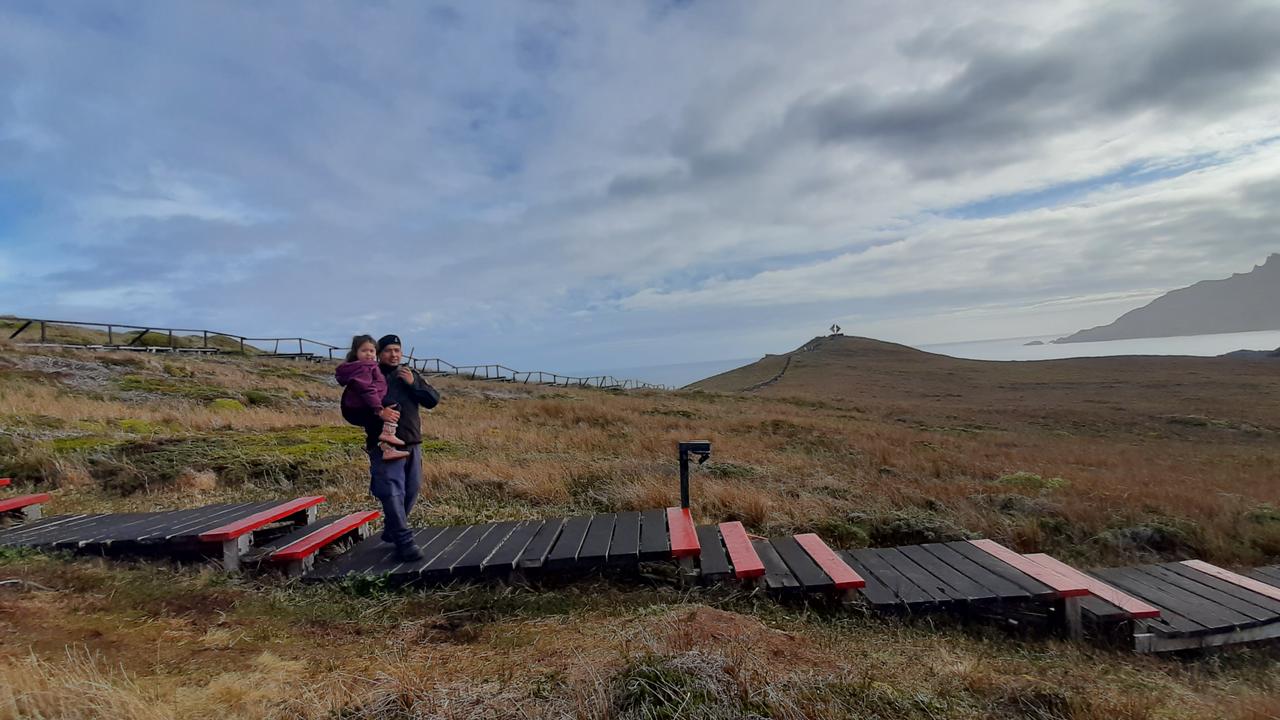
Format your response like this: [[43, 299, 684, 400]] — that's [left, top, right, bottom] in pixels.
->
[[365, 334, 440, 562]]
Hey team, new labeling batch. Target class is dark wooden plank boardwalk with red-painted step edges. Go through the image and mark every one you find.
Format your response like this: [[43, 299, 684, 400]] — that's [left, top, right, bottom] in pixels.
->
[[0, 497, 1280, 652]]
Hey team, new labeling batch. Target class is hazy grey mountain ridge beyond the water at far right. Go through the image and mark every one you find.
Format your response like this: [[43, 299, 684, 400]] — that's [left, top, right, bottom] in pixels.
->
[[1053, 252, 1280, 343]]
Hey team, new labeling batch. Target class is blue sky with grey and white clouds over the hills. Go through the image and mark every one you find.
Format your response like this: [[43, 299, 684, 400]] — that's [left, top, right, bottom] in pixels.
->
[[0, 0, 1280, 370]]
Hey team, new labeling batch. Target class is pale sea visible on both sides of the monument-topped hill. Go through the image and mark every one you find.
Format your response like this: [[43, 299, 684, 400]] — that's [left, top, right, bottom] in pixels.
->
[[586, 331, 1280, 387]]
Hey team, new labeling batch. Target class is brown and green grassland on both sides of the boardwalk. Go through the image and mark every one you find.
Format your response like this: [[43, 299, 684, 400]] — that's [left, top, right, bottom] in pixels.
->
[[0, 347, 1280, 720]]
